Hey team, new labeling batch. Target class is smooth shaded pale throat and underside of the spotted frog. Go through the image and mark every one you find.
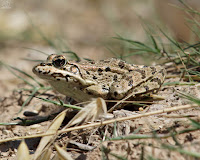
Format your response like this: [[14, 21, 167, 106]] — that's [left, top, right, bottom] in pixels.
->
[[48, 80, 97, 102]]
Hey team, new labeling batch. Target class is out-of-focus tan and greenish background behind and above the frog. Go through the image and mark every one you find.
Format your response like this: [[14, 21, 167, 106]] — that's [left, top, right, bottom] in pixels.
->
[[0, 0, 200, 95]]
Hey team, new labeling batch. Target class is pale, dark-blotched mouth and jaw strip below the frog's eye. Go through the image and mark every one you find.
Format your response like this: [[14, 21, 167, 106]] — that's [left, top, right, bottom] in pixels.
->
[[32, 65, 96, 86]]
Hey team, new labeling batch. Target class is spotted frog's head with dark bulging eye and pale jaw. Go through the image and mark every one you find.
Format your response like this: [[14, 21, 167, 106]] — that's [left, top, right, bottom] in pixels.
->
[[33, 54, 94, 86]]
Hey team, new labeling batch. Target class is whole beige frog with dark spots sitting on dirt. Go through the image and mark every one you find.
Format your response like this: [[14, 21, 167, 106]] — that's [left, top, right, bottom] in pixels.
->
[[32, 54, 166, 102]]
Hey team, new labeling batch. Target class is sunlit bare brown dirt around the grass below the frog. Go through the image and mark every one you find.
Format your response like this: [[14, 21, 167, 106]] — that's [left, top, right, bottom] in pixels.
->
[[0, 79, 200, 159]]
